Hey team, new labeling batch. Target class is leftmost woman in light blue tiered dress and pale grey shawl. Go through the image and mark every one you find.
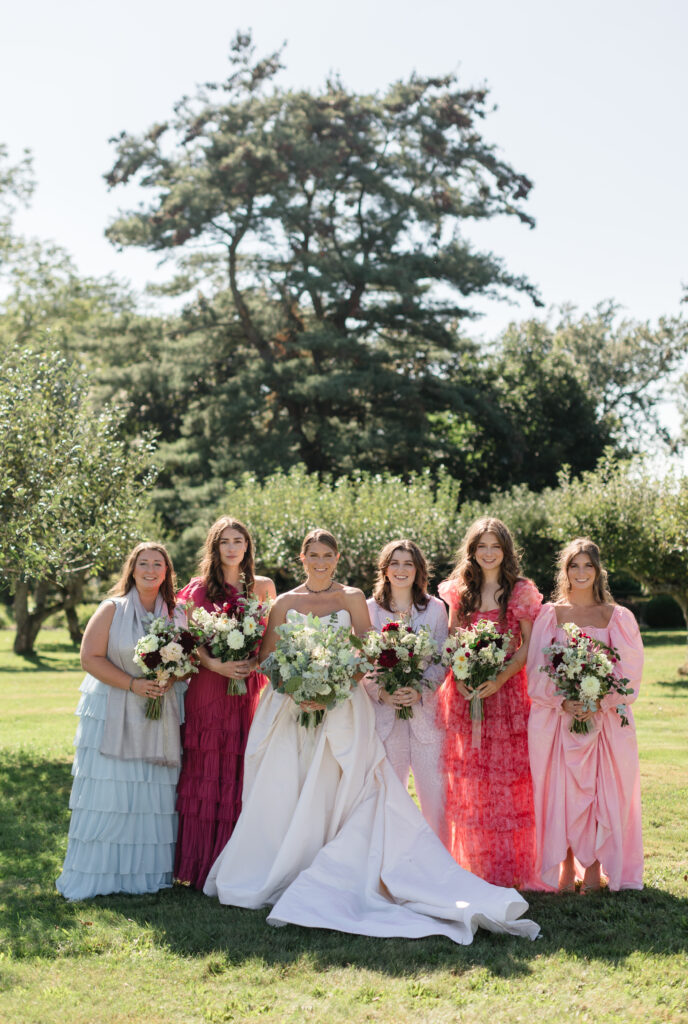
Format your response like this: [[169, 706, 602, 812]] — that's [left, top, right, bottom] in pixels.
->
[[56, 544, 186, 900]]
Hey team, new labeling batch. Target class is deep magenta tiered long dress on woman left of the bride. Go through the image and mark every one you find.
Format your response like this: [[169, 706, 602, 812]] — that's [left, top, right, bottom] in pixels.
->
[[174, 578, 266, 889]]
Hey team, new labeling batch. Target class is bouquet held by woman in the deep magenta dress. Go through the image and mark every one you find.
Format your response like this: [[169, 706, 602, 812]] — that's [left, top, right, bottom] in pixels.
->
[[194, 594, 269, 696]]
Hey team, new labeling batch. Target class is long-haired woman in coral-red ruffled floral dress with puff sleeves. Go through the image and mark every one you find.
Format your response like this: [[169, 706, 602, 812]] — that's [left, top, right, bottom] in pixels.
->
[[437, 517, 543, 889]]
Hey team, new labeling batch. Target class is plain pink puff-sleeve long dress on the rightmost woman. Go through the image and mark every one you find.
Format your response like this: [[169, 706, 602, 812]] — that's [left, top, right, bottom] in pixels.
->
[[528, 604, 643, 890]]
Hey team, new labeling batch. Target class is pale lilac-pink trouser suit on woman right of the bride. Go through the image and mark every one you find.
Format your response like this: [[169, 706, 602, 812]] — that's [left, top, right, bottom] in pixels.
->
[[364, 597, 448, 835]]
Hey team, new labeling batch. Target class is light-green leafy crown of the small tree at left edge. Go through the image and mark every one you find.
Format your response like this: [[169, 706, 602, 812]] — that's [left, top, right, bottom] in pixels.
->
[[0, 346, 153, 653]]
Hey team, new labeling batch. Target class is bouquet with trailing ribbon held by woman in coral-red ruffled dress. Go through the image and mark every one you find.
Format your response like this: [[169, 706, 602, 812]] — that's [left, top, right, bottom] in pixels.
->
[[442, 618, 512, 746]]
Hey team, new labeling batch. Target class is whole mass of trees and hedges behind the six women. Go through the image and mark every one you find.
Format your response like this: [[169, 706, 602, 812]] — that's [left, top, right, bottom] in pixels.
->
[[0, 41, 688, 651]]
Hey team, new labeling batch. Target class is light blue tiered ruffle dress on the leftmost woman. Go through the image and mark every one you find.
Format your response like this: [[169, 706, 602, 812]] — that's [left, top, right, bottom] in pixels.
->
[[56, 598, 186, 900]]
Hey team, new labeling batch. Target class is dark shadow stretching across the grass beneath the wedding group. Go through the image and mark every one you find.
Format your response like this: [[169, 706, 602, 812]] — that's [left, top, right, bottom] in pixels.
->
[[0, 753, 688, 977]]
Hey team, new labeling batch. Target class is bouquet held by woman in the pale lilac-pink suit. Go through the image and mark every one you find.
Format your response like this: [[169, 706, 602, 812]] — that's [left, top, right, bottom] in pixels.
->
[[363, 623, 437, 719]]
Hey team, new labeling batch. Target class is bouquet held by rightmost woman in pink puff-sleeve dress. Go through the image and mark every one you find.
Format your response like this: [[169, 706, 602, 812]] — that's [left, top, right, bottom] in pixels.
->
[[540, 623, 633, 734]]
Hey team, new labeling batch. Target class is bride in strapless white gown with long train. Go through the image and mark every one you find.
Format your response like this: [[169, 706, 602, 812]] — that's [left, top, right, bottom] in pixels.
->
[[204, 530, 540, 944]]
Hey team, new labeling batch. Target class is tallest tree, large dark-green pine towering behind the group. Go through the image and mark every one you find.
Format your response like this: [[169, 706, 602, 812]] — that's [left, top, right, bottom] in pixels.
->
[[106, 36, 536, 495]]
